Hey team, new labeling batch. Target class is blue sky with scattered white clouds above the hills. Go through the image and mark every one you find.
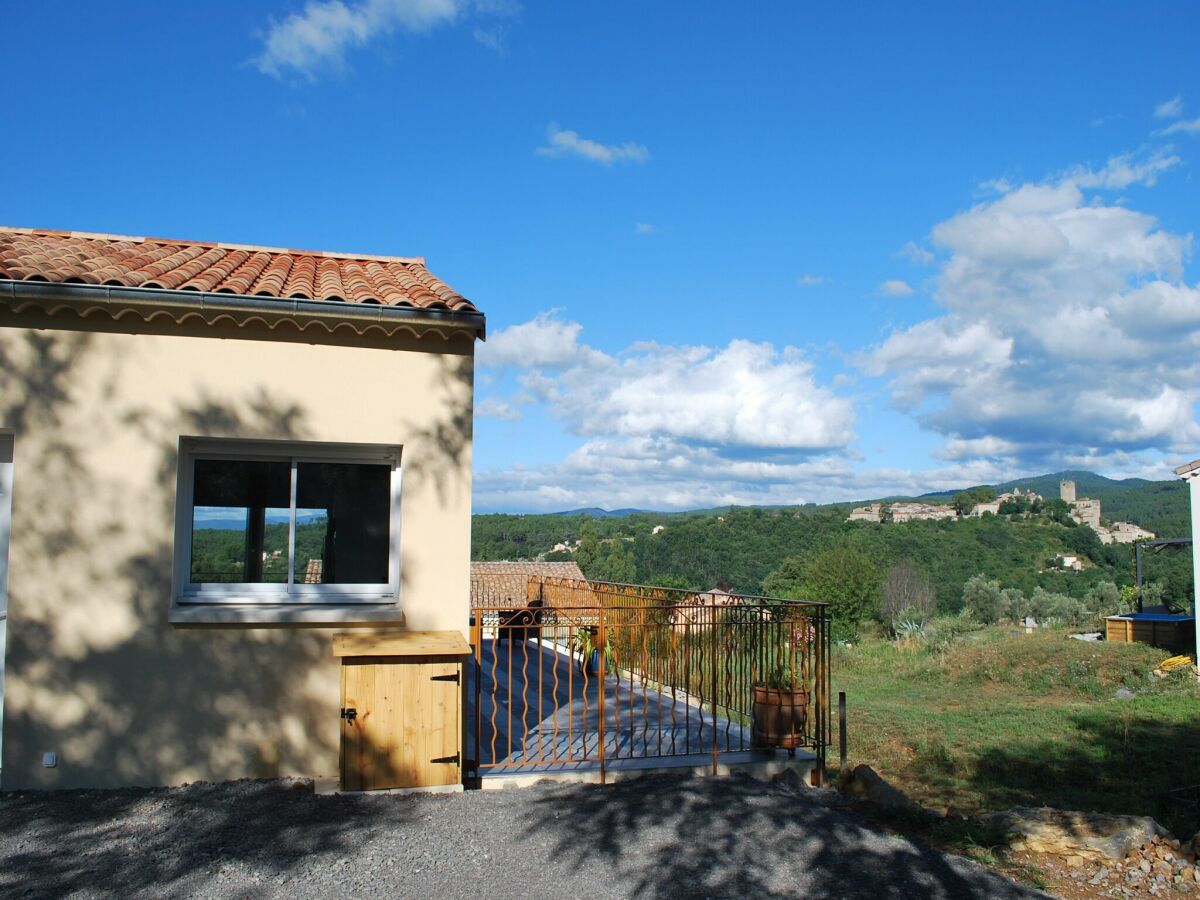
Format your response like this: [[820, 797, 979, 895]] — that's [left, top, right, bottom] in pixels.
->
[[7, 0, 1200, 511]]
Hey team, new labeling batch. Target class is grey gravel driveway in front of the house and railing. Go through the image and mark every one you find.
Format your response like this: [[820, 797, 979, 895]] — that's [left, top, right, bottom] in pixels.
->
[[0, 775, 1044, 900]]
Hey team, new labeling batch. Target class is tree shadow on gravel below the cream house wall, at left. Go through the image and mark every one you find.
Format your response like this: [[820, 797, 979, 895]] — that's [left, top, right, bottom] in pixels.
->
[[0, 781, 416, 896]]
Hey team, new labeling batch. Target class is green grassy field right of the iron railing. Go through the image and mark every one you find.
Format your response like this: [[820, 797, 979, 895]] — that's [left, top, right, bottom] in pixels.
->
[[833, 628, 1200, 839]]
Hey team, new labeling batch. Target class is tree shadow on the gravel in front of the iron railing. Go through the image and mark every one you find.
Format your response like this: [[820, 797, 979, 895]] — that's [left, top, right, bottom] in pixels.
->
[[529, 775, 1042, 900]]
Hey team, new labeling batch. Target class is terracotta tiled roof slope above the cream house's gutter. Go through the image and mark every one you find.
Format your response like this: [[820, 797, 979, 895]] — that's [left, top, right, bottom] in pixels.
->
[[0, 226, 478, 312]]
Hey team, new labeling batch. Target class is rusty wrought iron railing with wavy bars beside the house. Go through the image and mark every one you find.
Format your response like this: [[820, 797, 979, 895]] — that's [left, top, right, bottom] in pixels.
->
[[468, 576, 830, 778]]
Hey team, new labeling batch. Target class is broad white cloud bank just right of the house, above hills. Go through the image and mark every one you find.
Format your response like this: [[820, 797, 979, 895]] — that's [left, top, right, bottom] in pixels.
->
[[476, 311, 854, 509]]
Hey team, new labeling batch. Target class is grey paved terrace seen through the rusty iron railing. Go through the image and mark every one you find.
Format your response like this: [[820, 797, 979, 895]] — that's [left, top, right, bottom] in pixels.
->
[[467, 640, 750, 774]]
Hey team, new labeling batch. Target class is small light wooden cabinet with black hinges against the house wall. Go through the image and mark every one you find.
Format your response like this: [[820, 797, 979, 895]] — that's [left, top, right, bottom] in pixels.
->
[[334, 631, 470, 791]]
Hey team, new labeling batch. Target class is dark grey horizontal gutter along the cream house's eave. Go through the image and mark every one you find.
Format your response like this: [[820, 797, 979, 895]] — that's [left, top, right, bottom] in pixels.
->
[[0, 278, 486, 340]]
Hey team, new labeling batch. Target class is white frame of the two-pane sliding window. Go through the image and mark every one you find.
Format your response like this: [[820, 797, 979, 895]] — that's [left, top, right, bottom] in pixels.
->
[[172, 437, 403, 606]]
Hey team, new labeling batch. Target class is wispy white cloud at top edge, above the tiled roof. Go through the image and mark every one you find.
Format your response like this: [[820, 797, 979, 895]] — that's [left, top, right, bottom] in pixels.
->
[[253, 0, 520, 80]]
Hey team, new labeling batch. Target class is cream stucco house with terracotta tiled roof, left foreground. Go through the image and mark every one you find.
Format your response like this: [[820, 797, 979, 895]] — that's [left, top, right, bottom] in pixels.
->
[[0, 228, 485, 788]]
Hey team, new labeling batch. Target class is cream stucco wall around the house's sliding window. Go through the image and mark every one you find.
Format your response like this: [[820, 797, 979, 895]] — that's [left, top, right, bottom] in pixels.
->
[[0, 316, 473, 790]]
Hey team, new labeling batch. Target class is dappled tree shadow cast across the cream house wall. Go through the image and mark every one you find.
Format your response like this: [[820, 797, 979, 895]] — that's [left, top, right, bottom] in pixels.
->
[[0, 330, 469, 801]]
